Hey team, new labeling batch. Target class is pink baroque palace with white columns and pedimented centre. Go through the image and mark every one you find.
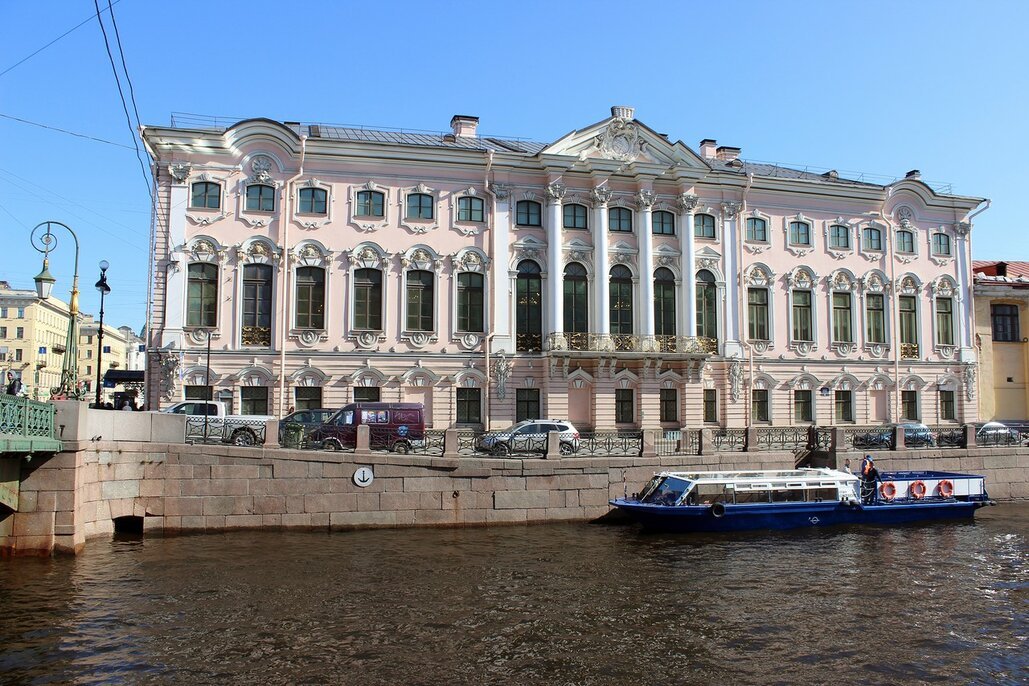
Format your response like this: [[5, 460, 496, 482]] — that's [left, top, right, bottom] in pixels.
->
[[143, 107, 984, 429]]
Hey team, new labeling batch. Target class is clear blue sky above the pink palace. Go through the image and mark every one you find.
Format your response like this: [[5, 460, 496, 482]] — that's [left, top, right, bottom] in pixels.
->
[[0, 0, 1029, 329]]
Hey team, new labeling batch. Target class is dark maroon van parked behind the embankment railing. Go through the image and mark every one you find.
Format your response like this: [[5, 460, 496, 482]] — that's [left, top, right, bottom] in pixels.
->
[[309, 402, 425, 455]]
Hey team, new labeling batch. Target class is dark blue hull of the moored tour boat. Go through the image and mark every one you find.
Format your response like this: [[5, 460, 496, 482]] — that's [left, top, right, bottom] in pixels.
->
[[610, 498, 988, 532]]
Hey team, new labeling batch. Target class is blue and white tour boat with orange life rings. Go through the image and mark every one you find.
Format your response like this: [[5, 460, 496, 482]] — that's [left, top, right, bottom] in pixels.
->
[[610, 468, 993, 532]]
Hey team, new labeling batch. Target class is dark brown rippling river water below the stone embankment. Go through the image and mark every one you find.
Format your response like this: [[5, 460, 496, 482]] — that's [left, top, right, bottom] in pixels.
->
[[0, 504, 1029, 685]]
